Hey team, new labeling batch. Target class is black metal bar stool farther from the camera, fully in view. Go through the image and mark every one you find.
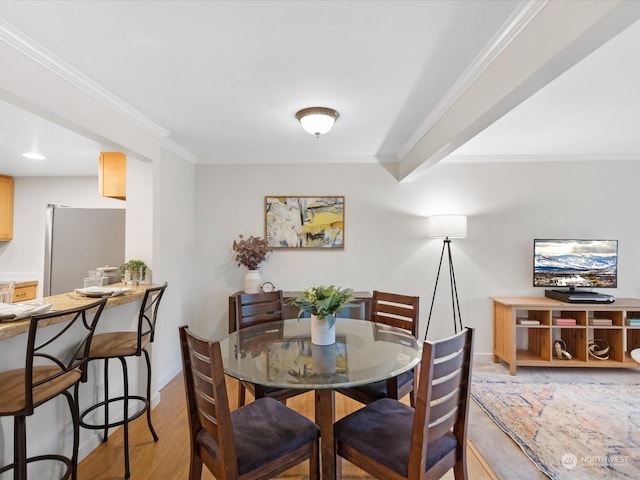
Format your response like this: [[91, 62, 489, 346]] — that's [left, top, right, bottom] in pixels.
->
[[76, 282, 167, 478]]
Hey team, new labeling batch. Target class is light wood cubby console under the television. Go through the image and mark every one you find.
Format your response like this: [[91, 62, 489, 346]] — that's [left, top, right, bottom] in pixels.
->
[[491, 297, 640, 375]]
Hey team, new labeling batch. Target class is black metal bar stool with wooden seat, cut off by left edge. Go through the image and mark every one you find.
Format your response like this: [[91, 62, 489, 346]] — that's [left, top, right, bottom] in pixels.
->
[[0, 298, 107, 480]]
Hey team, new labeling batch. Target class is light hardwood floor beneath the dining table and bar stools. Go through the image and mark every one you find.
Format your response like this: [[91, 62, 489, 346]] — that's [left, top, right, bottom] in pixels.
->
[[78, 374, 497, 480]]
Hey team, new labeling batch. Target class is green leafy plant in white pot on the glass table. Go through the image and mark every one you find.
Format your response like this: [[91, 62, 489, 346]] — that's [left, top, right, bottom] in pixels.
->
[[287, 285, 355, 345]]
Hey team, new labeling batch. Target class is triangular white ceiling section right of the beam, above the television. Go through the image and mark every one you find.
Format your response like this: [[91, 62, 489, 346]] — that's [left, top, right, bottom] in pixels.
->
[[453, 8, 640, 161]]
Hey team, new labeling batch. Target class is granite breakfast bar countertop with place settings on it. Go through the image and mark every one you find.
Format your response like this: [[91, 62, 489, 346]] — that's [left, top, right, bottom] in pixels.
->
[[0, 282, 157, 340]]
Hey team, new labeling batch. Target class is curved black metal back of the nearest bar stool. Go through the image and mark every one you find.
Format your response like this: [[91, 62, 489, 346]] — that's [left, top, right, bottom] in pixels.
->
[[25, 298, 107, 415]]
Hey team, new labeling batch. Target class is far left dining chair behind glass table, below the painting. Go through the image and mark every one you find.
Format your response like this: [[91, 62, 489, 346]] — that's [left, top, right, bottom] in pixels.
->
[[236, 290, 307, 407]]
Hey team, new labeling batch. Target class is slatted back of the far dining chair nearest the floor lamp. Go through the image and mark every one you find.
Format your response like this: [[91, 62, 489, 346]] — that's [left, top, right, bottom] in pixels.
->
[[371, 290, 420, 337]]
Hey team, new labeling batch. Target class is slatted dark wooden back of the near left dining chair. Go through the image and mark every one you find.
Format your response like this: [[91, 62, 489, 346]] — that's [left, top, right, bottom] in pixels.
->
[[180, 326, 238, 478]]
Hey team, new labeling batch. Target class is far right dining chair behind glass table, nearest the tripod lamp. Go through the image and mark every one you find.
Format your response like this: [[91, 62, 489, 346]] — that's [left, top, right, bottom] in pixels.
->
[[336, 290, 420, 407]]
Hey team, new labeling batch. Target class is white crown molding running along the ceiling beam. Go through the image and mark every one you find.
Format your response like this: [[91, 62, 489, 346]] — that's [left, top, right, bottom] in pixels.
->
[[398, 0, 549, 158]]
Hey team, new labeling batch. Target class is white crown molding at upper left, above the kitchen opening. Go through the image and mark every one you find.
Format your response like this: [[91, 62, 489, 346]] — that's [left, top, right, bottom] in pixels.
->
[[0, 17, 195, 152]]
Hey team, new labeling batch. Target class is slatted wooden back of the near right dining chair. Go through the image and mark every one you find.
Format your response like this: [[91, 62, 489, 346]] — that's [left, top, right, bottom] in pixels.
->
[[409, 328, 473, 471]]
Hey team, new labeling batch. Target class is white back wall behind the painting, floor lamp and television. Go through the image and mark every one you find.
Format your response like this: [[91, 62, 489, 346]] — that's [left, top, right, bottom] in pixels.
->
[[193, 162, 640, 355]]
